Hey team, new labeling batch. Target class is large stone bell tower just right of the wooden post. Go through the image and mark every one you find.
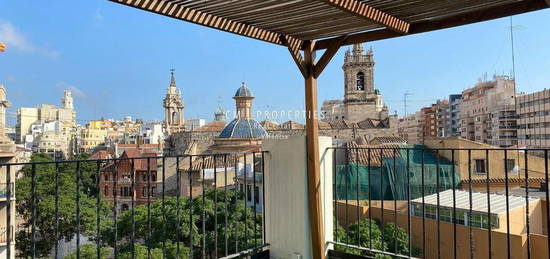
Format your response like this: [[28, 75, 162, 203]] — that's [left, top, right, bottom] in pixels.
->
[[321, 44, 397, 126]]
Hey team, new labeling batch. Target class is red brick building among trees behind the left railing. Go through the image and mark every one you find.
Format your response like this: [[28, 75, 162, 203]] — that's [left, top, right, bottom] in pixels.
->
[[99, 148, 159, 211]]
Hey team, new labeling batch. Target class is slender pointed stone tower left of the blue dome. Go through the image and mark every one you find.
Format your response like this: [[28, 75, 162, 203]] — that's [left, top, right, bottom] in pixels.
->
[[163, 69, 185, 133]]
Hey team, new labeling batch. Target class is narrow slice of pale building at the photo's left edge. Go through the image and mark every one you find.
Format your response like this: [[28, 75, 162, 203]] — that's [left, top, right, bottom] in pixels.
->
[[0, 85, 17, 259]]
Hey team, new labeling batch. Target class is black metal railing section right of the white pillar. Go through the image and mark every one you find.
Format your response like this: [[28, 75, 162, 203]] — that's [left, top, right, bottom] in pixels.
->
[[329, 145, 550, 258]]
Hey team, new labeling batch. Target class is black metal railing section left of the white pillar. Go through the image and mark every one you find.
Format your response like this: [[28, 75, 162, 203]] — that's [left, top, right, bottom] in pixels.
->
[[0, 151, 268, 258]]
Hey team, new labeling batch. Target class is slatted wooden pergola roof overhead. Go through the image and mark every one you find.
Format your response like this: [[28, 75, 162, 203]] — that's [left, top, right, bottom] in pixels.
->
[[110, 0, 550, 49]]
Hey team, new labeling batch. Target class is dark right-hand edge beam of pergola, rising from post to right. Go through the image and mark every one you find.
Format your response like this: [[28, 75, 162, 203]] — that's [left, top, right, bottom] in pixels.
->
[[315, 0, 550, 50]]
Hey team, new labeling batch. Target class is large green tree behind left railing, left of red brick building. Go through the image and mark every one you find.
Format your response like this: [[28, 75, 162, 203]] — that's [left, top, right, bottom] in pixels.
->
[[16, 154, 111, 257]]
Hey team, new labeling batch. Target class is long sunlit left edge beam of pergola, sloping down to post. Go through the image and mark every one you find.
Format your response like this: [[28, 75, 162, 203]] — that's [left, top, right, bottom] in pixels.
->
[[109, 0, 301, 45]]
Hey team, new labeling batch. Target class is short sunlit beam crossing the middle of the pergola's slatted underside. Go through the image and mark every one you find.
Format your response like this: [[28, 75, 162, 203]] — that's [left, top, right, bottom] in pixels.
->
[[317, 0, 410, 34]]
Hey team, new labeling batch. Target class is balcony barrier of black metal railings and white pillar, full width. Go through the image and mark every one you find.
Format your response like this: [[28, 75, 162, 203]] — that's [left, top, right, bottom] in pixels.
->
[[0, 137, 550, 258]]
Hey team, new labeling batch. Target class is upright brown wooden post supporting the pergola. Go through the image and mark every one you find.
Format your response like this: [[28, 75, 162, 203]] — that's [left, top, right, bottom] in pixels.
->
[[303, 41, 325, 259]]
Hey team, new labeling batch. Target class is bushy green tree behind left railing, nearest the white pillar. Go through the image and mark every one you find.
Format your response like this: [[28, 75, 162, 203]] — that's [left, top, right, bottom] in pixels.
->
[[110, 190, 262, 258]]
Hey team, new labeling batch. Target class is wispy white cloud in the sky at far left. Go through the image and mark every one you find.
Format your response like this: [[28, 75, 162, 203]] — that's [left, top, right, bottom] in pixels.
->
[[0, 21, 59, 58]]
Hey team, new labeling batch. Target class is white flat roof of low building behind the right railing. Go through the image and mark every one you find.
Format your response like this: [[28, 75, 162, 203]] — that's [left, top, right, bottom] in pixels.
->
[[412, 189, 539, 215]]
